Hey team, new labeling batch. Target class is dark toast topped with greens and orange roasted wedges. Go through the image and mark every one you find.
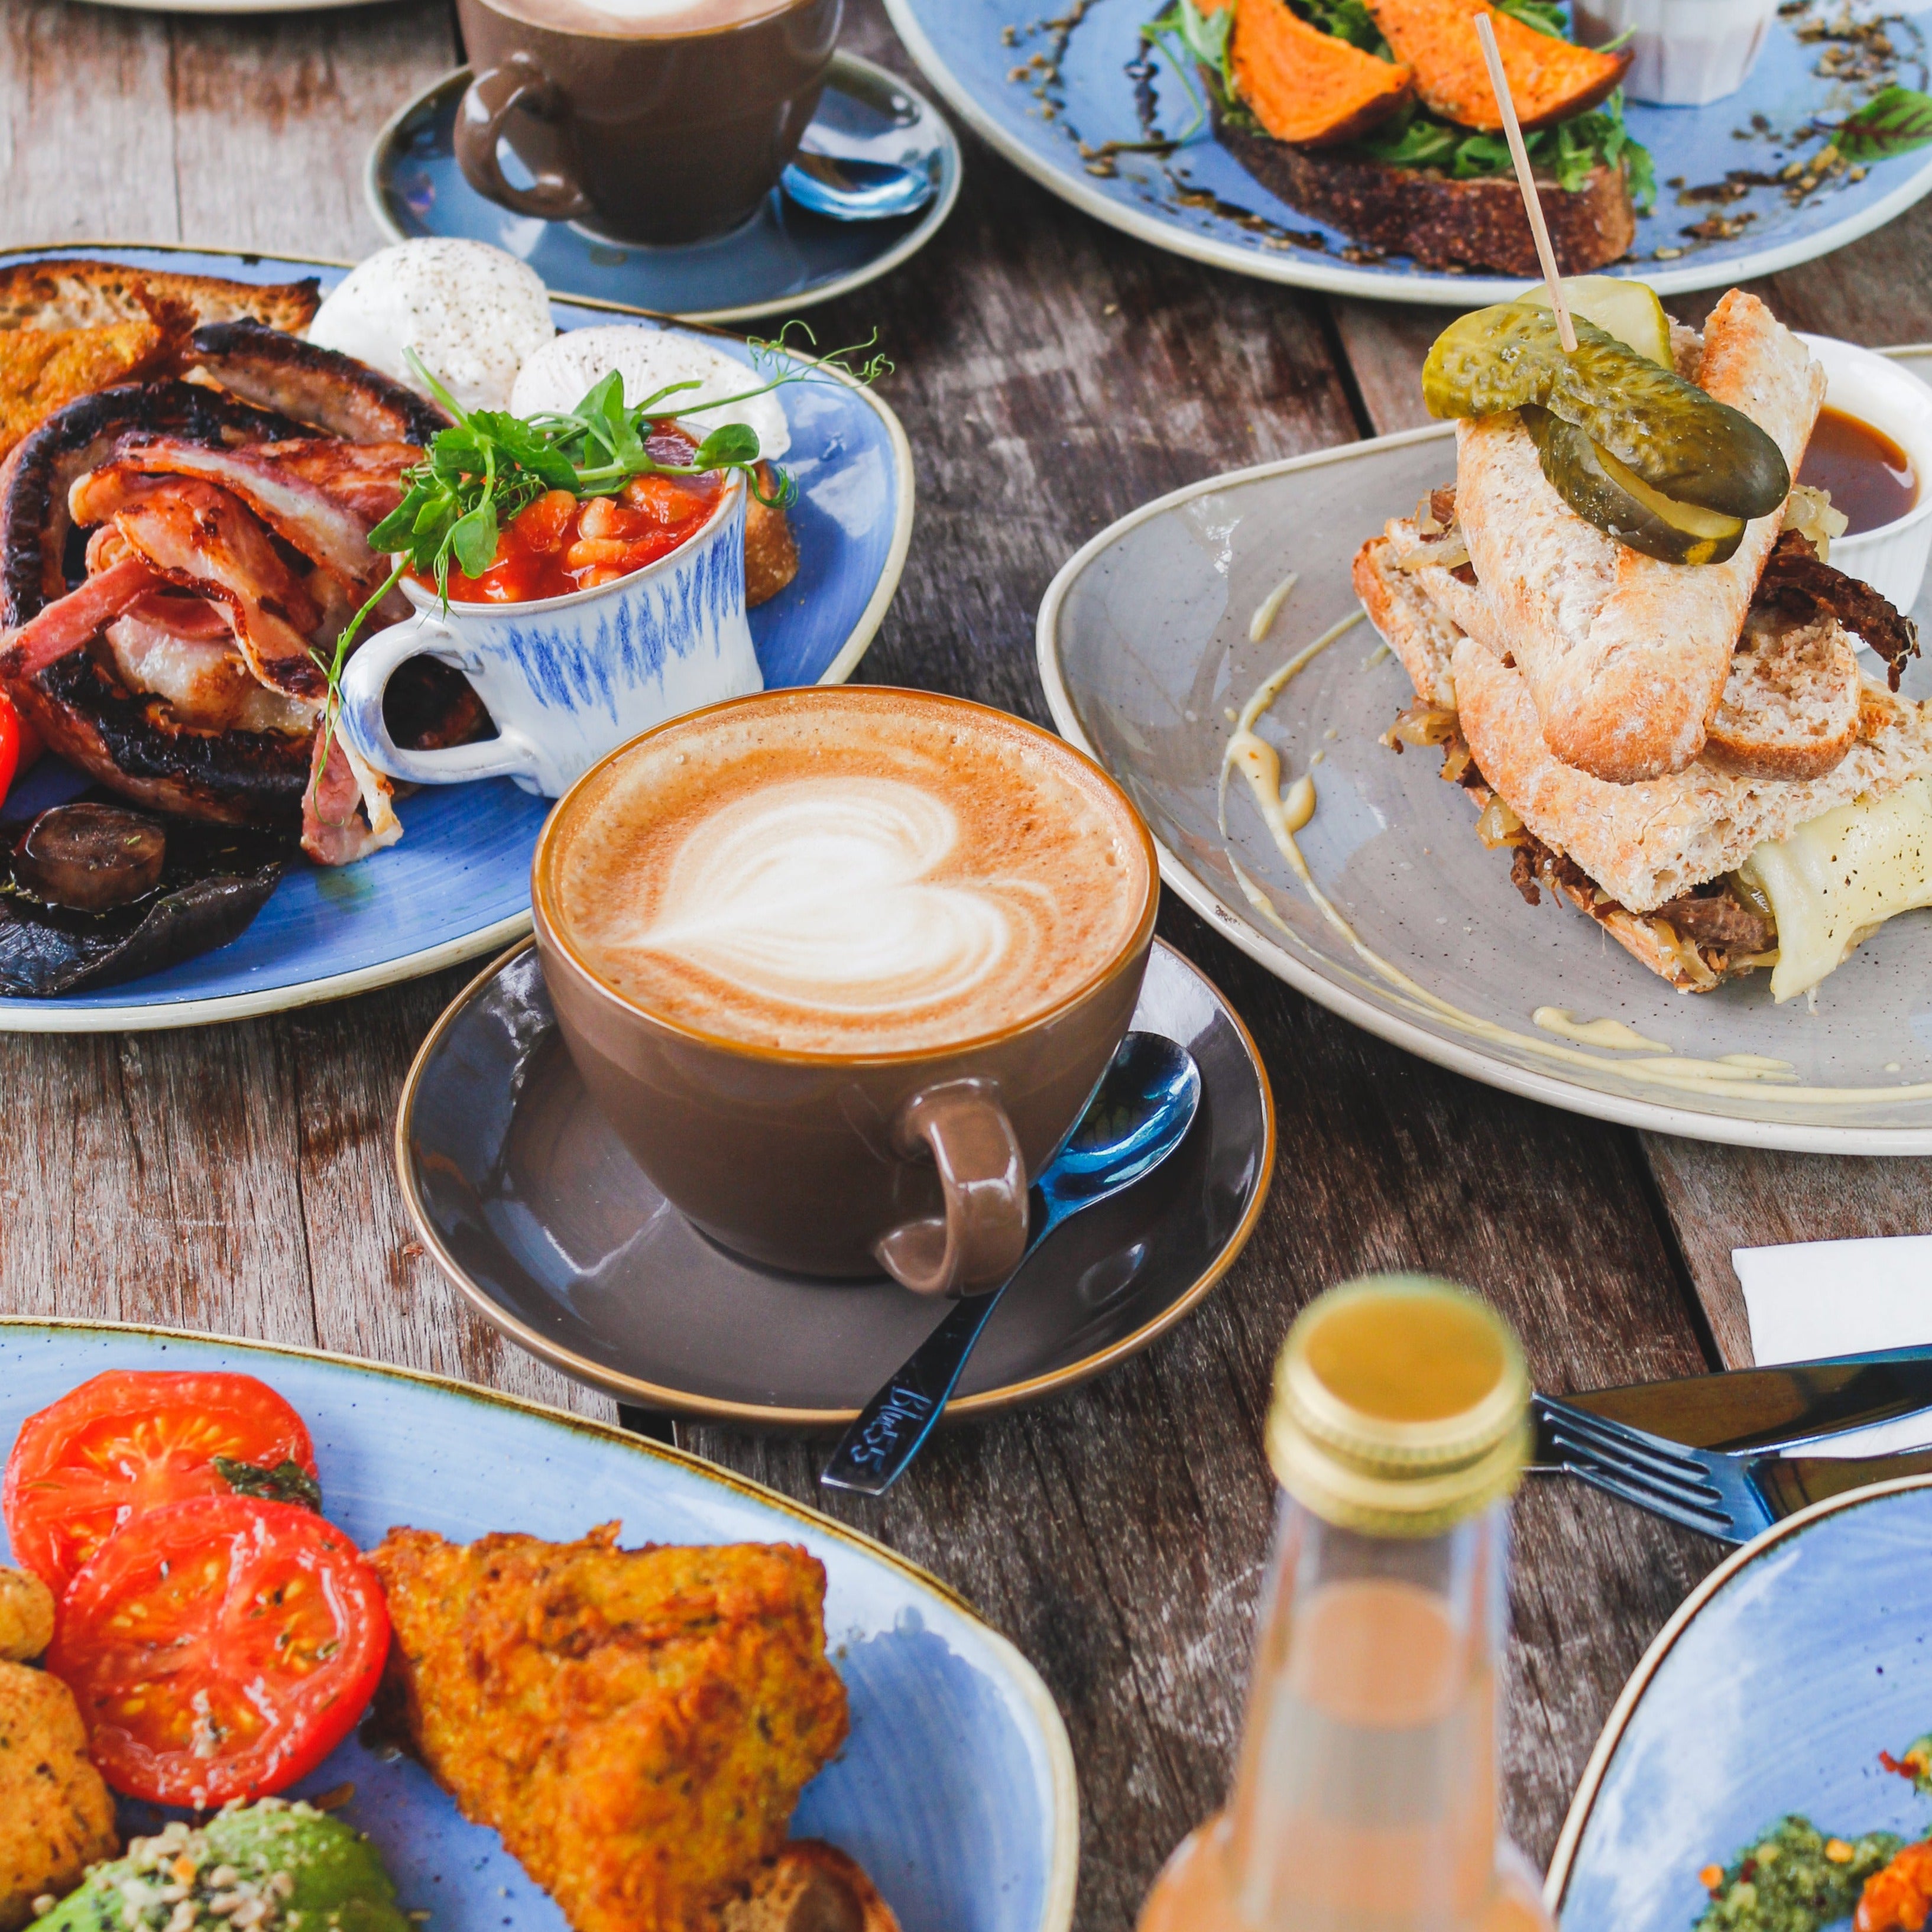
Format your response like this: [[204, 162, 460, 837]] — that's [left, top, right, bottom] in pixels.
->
[[1147, 0, 1654, 276]]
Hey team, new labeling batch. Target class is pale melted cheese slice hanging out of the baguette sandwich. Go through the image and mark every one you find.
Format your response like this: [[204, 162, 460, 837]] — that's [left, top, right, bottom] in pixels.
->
[[1740, 779, 1932, 1003]]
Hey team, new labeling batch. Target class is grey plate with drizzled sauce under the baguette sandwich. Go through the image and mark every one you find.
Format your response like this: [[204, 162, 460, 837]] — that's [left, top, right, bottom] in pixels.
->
[[1038, 423, 1932, 1153]]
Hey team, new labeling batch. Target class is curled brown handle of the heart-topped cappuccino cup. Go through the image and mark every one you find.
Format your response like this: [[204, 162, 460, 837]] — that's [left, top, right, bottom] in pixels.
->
[[871, 1080, 1028, 1295]]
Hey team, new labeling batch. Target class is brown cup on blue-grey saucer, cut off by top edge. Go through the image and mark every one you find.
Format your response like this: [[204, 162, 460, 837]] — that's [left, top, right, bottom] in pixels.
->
[[456, 0, 842, 244]]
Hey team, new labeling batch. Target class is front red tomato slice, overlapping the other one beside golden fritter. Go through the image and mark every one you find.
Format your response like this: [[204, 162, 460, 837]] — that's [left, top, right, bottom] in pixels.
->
[[46, 1495, 388, 1810]]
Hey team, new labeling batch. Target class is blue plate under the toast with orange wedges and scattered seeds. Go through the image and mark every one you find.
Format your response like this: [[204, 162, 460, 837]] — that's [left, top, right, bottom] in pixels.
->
[[885, 0, 1932, 307]]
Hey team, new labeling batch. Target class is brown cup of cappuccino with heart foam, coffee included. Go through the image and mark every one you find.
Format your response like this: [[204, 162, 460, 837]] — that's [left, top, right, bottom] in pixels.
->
[[531, 686, 1159, 1295]]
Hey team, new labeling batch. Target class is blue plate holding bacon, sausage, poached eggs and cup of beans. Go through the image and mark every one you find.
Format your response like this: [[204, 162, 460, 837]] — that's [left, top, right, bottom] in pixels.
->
[[0, 244, 912, 1033]]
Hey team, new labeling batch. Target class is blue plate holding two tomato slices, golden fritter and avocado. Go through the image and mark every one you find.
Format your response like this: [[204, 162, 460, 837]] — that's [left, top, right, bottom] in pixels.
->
[[0, 1321, 1080, 1932]]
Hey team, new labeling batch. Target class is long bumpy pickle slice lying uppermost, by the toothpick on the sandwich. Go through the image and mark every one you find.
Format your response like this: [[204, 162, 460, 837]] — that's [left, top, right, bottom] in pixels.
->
[[1422, 302, 1791, 520]]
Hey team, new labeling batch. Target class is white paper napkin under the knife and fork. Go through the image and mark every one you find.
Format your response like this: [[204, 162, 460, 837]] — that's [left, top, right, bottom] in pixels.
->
[[1731, 1234, 1932, 1455]]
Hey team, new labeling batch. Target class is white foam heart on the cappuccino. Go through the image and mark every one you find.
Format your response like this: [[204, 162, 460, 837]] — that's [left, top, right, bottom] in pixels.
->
[[636, 779, 1039, 1014]]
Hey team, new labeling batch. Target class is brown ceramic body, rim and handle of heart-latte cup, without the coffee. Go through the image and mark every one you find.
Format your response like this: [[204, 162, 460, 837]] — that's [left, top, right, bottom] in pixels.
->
[[531, 686, 1159, 1295]]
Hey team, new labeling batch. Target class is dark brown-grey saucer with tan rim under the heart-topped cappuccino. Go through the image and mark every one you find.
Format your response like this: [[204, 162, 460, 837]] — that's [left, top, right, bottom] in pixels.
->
[[396, 941, 1275, 1429]]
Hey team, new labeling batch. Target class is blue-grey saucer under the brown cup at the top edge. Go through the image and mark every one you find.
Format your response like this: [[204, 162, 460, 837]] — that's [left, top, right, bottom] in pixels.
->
[[363, 54, 960, 325]]
